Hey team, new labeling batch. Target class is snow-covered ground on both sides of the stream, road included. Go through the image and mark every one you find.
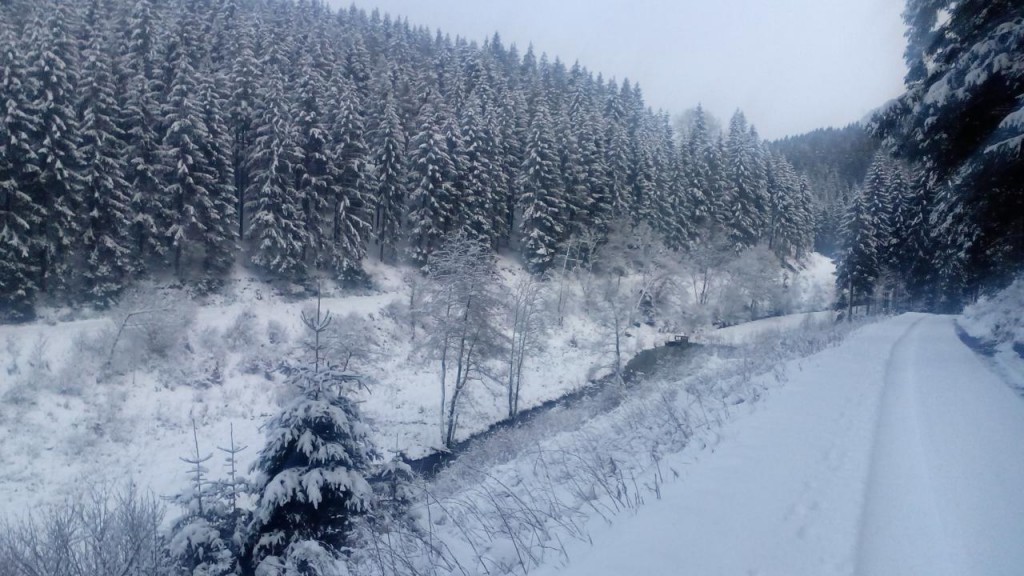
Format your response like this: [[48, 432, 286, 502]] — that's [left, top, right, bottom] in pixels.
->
[[9, 251, 1024, 575]]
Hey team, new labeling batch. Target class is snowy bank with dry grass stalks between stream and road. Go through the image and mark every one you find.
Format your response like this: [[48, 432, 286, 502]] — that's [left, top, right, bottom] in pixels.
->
[[351, 313, 856, 575]]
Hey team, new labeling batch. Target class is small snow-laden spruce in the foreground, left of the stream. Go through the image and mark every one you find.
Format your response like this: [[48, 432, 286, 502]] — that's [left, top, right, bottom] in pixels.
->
[[243, 302, 378, 576]]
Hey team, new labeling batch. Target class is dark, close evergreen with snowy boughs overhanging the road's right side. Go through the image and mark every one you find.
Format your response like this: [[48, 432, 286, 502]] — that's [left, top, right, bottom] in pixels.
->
[[876, 0, 1024, 308]]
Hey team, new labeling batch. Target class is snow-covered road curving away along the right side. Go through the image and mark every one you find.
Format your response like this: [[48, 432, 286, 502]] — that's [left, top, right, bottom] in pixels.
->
[[539, 315, 1024, 576]]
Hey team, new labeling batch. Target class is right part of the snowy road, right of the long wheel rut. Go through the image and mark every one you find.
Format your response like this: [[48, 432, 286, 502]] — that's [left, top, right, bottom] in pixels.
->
[[857, 316, 1024, 576]]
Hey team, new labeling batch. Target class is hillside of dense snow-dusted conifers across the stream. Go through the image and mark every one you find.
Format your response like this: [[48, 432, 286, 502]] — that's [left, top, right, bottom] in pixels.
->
[[0, 0, 813, 320]]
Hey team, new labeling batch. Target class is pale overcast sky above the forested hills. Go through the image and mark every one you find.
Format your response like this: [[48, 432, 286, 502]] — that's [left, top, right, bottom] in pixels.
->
[[331, 0, 904, 138]]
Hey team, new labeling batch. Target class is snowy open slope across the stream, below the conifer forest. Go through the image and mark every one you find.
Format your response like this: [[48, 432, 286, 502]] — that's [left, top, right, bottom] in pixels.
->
[[0, 258, 665, 517]]
